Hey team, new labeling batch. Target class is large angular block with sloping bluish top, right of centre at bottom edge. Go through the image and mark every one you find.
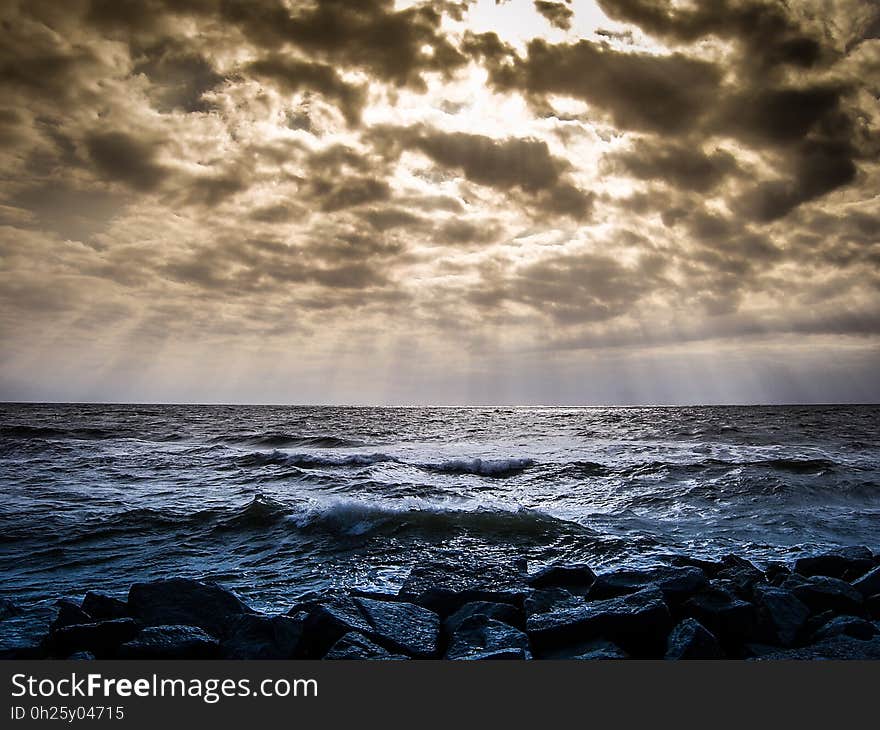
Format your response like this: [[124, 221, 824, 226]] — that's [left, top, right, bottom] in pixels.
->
[[526, 588, 672, 656]]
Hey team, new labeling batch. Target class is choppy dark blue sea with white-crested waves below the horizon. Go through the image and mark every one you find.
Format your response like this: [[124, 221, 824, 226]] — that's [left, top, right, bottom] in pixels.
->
[[0, 404, 880, 640]]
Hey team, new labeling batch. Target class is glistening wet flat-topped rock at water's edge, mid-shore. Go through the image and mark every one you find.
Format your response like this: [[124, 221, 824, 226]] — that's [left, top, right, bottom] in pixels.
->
[[398, 560, 528, 617]]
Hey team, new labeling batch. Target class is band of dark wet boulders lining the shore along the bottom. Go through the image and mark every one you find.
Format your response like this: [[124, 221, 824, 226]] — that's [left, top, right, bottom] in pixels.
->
[[0, 547, 880, 660]]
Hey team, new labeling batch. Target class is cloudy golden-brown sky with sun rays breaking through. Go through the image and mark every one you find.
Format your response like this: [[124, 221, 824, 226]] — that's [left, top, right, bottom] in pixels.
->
[[0, 0, 880, 405]]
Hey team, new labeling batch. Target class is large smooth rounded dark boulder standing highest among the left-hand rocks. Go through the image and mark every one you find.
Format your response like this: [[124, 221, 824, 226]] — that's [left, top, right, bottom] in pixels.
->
[[128, 578, 252, 636]]
